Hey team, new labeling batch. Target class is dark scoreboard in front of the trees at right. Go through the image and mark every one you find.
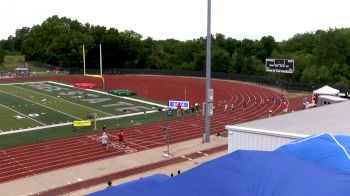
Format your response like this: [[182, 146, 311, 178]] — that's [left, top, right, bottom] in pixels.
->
[[265, 59, 294, 73]]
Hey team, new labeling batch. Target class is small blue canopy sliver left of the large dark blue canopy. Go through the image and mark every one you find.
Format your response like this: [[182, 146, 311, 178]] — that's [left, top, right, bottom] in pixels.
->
[[89, 174, 170, 196]]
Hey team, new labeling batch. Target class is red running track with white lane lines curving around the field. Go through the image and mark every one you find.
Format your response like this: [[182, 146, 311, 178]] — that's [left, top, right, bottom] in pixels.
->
[[0, 75, 310, 183]]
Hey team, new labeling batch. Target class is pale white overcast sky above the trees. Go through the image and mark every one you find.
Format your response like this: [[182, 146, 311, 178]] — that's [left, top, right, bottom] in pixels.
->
[[0, 0, 350, 41]]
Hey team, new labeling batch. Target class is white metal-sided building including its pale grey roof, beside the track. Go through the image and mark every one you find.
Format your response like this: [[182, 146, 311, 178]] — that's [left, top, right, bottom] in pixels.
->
[[225, 101, 350, 152]]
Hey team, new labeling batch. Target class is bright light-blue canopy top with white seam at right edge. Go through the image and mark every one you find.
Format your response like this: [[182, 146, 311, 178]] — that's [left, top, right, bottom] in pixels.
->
[[275, 133, 350, 173]]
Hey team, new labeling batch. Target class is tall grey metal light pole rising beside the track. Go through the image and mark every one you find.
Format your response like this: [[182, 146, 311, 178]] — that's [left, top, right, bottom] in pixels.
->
[[204, 0, 211, 143]]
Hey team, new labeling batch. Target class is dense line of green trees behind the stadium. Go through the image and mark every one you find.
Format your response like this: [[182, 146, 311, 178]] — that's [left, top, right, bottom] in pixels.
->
[[0, 16, 350, 86]]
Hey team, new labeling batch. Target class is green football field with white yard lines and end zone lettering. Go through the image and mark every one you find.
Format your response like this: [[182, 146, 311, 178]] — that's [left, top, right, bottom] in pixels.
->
[[0, 81, 165, 133]]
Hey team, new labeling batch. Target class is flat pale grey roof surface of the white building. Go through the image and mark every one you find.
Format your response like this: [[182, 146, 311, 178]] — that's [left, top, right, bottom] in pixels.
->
[[235, 101, 350, 135]]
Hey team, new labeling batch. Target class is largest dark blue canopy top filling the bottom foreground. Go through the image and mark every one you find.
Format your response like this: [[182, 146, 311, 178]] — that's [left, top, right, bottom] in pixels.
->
[[87, 150, 350, 196]]
